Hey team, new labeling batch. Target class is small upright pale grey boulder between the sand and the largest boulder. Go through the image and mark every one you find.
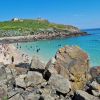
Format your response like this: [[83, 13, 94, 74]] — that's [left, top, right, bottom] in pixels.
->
[[31, 56, 45, 70]]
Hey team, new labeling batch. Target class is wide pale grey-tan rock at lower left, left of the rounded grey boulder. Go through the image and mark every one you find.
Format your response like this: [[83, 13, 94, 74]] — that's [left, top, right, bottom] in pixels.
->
[[15, 71, 45, 88]]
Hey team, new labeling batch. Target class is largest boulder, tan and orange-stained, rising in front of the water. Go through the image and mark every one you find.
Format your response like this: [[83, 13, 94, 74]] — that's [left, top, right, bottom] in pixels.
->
[[45, 46, 89, 90]]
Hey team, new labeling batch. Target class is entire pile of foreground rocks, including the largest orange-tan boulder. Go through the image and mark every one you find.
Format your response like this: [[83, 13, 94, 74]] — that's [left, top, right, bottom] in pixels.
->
[[0, 46, 100, 100]]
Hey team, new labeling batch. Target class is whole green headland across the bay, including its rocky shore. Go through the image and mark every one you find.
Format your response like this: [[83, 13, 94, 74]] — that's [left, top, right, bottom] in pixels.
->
[[0, 18, 86, 41]]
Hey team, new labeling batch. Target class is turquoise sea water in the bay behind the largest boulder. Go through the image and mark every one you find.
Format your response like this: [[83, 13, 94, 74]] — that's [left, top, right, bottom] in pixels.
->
[[16, 29, 100, 66]]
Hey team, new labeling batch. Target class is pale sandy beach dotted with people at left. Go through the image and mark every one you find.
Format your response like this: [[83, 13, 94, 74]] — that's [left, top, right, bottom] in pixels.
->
[[0, 44, 30, 64]]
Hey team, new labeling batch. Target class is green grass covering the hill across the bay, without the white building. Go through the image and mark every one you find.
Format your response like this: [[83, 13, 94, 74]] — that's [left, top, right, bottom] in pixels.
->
[[0, 19, 78, 36]]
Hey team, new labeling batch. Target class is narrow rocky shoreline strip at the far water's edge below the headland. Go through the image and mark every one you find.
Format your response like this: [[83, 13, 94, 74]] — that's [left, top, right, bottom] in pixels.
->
[[0, 32, 89, 44]]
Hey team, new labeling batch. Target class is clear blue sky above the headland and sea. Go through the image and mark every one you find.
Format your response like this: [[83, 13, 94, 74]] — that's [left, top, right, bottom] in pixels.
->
[[0, 0, 100, 29]]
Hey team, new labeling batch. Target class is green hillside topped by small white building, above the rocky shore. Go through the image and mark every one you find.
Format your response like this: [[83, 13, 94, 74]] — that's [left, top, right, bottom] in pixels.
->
[[0, 18, 80, 37]]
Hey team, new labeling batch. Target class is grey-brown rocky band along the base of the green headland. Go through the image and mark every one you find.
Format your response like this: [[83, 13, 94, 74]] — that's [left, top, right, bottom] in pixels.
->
[[0, 30, 87, 43]]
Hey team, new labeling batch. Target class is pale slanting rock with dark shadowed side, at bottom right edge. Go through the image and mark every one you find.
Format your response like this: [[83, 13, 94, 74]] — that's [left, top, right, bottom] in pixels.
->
[[74, 90, 100, 100]]
